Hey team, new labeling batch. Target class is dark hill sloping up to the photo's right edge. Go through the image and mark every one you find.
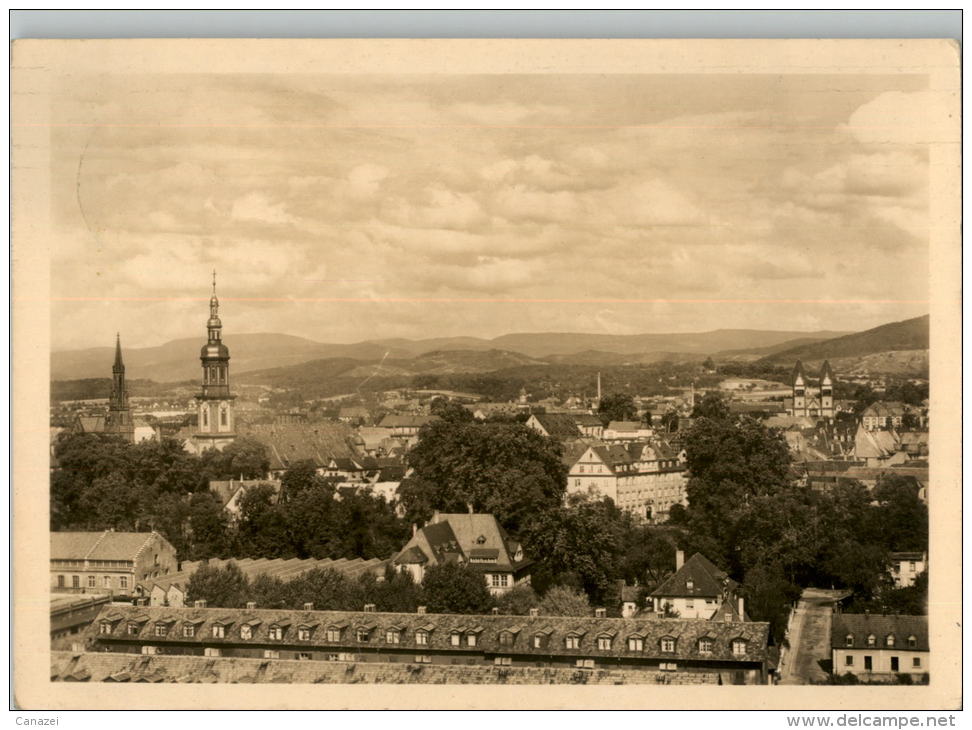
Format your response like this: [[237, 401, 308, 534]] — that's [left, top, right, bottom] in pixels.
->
[[762, 315, 929, 366]]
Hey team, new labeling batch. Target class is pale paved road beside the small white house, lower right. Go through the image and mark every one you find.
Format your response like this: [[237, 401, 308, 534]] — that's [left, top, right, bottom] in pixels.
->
[[780, 588, 838, 684]]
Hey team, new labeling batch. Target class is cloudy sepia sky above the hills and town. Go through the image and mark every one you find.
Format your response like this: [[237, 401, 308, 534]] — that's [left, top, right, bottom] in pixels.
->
[[52, 73, 928, 349]]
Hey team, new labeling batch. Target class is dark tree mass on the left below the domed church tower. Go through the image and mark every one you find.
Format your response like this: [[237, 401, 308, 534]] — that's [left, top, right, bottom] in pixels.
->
[[51, 434, 408, 560]]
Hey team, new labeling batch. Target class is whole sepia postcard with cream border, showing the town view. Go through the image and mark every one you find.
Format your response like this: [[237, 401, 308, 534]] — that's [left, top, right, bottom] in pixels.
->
[[11, 40, 962, 710]]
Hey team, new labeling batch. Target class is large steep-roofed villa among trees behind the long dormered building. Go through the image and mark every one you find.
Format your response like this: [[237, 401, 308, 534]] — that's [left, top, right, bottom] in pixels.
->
[[392, 512, 533, 595]]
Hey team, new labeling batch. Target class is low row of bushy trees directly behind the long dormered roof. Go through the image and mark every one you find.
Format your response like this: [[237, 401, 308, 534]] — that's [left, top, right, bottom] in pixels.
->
[[186, 562, 592, 616]]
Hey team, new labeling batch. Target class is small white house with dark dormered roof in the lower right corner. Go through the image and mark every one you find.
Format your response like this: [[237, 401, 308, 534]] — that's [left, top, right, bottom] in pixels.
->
[[830, 613, 931, 682]]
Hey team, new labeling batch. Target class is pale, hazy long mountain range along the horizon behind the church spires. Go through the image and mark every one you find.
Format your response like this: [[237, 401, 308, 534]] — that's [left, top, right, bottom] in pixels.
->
[[51, 330, 846, 382]]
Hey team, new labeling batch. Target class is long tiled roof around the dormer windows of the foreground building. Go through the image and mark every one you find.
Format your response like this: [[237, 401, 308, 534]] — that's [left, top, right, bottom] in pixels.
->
[[91, 606, 769, 662]]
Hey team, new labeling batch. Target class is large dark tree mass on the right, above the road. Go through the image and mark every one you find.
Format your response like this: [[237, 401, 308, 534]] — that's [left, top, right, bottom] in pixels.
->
[[672, 402, 928, 638]]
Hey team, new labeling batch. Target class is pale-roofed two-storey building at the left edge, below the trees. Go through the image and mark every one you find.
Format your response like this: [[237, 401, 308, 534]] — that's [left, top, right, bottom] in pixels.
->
[[51, 530, 177, 596]]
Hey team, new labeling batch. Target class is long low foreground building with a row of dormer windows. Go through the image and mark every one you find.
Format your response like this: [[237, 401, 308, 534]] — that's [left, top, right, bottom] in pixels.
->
[[88, 606, 769, 684]]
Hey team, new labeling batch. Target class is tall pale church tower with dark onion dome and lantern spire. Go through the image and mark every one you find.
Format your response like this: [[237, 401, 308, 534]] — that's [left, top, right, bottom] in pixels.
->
[[193, 271, 236, 452]]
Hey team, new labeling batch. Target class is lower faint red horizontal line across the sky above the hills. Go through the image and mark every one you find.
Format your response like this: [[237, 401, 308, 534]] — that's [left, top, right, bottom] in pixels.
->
[[41, 297, 929, 304]]
